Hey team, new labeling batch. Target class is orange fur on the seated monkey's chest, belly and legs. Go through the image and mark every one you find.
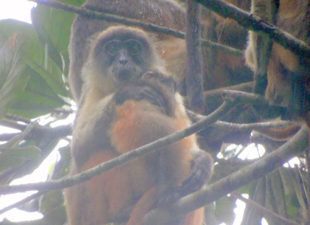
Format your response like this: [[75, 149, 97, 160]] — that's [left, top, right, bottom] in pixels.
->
[[66, 84, 204, 225]]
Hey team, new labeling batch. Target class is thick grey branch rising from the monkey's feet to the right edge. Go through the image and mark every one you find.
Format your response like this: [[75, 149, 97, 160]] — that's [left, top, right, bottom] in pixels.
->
[[144, 127, 308, 225]]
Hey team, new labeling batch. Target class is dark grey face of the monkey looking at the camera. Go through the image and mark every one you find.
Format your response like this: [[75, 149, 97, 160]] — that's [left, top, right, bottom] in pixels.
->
[[95, 28, 153, 83]]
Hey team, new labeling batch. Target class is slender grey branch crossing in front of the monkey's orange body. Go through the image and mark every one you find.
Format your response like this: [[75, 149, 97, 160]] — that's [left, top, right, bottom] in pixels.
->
[[0, 101, 235, 194]]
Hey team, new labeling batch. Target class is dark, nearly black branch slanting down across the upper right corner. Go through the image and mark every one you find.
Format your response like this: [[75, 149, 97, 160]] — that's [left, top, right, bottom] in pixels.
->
[[197, 0, 310, 57]]
